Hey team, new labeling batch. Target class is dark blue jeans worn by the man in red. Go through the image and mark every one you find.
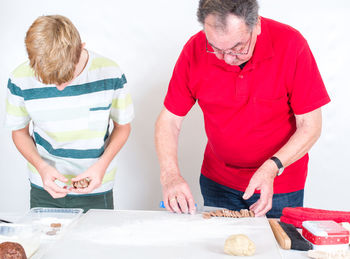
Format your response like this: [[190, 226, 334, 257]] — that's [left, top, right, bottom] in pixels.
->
[[199, 174, 304, 218]]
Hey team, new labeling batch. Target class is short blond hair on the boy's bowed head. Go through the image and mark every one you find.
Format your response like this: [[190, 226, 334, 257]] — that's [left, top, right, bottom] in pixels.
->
[[25, 15, 82, 85]]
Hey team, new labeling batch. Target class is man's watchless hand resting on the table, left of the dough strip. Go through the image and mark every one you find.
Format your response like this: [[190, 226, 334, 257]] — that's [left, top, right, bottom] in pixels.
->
[[162, 175, 196, 214]]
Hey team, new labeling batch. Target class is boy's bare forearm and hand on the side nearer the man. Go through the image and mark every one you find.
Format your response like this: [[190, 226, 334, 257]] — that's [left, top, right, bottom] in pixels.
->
[[71, 121, 131, 193]]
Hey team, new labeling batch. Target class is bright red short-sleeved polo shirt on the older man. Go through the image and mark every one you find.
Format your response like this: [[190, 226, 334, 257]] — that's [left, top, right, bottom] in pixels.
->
[[164, 18, 330, 193]]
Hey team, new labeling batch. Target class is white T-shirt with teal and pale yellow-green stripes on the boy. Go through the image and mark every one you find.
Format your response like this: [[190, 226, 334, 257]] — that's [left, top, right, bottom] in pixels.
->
[[5, 51, 134, 193]]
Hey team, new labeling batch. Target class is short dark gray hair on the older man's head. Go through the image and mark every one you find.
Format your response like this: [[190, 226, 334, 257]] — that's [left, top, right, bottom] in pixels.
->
[[197, 0, 259, 29]]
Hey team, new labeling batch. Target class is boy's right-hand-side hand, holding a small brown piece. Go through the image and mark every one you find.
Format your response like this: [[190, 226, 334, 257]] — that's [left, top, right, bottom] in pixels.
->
[[70, 162, 105, 194]]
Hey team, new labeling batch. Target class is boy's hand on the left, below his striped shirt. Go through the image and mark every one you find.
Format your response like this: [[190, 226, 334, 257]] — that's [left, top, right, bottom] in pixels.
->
[[38, 163, 69, 199]]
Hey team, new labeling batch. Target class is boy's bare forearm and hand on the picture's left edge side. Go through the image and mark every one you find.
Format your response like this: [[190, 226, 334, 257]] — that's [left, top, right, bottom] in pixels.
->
[[12, 124, 69, 199]]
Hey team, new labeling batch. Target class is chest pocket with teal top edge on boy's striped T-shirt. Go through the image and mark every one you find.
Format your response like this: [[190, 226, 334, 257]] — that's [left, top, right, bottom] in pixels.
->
[[88, 102, 111, 131]]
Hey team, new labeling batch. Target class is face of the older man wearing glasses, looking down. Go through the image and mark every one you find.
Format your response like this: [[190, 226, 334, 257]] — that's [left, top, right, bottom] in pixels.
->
[[204, 15, 260, 66]]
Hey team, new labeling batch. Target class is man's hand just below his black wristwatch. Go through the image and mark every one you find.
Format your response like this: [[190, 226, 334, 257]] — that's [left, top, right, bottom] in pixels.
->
[[243, 159, 278, 217]]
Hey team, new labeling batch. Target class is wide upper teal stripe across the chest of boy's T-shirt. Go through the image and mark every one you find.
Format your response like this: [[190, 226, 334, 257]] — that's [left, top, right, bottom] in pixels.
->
[[18, 75, 126, 101]]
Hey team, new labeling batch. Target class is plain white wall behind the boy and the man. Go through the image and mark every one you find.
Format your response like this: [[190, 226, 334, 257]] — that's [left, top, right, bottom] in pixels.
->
[[0, 0, 350, 213]]
